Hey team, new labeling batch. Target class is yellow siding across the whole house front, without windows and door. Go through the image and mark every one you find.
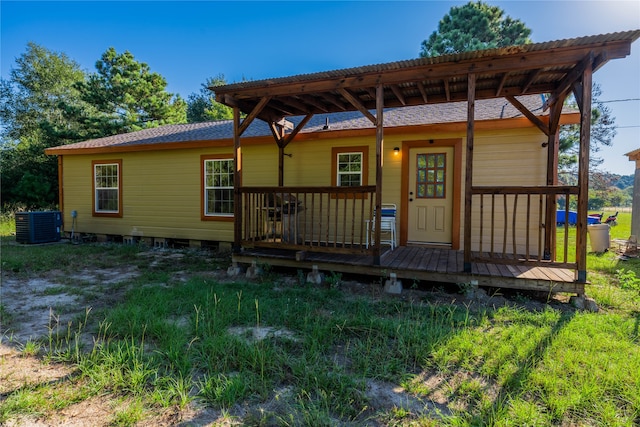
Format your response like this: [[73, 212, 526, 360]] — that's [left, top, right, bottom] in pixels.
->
[[58, 128, 546, 250]]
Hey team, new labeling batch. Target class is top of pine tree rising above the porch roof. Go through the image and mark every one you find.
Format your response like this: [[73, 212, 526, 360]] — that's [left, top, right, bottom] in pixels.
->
[[420, 1, 531, 57]]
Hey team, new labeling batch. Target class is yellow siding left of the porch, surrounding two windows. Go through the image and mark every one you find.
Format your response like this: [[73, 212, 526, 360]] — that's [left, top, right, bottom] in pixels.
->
[[63, 149, 233, 241]]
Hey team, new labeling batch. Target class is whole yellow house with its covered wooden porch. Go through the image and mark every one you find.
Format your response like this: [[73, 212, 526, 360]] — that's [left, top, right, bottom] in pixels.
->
[[47, 31, 640, 294]]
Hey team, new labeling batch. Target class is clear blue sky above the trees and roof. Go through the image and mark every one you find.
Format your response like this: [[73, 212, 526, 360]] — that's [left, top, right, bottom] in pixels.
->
[[0, 0, 640, 175]]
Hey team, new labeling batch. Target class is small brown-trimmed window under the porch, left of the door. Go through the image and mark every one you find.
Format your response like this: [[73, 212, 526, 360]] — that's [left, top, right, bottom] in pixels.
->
[[331, 146, 369, 187]]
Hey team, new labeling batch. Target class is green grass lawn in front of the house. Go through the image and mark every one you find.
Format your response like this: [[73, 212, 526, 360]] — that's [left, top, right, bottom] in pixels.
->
[[0, 214, 640, 426]]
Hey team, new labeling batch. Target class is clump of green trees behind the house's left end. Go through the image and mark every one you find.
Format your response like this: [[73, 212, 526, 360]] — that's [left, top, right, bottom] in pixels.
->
[[0, 43, 186, 208]]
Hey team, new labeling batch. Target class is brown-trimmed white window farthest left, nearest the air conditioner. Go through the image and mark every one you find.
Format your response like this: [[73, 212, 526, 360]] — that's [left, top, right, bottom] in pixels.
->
[[93, 160, 122, 217]]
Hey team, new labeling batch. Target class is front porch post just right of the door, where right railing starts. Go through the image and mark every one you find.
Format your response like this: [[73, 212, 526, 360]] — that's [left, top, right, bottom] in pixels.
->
[[464, 74, 476, 273]]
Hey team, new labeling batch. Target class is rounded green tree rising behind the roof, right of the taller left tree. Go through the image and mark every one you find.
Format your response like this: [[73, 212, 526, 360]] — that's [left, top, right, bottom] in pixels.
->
[[78, 47, 187, 136]]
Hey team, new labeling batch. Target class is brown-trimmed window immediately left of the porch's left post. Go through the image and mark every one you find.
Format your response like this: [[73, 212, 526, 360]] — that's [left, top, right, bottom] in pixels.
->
[[202, 157, 234, 219]]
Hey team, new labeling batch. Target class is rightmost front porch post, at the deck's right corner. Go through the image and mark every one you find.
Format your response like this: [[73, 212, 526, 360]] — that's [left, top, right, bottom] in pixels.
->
[[576, 54, 593, 283]]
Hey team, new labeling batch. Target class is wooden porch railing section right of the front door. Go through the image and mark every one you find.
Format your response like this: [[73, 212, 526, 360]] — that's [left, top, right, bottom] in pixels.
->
[[471, 186, 586, 269]]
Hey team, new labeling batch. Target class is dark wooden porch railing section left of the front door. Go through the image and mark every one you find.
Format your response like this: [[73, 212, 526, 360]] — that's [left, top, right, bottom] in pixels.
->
[[239, 186, 376, 254]]
